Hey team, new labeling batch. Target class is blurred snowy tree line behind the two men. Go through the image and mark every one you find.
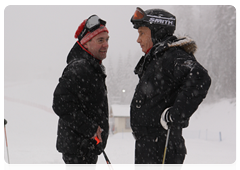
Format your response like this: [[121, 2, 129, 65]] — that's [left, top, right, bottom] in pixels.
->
[[106, 5, 238, 104]]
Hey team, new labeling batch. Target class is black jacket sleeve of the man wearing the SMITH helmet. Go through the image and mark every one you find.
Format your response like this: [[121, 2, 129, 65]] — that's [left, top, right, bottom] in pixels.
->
[[170, 58, 211, 123]]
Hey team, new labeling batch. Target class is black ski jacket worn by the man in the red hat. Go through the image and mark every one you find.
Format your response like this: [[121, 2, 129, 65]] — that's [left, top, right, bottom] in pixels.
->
[[52, 43, 109, 153]]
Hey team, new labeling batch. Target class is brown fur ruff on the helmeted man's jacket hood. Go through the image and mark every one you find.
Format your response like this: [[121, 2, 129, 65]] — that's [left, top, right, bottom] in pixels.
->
[[168, 36, 197, 54]]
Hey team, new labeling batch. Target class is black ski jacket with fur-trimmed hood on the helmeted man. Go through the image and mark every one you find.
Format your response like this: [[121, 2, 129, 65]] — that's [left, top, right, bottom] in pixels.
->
[[130, 36, 211, 135]]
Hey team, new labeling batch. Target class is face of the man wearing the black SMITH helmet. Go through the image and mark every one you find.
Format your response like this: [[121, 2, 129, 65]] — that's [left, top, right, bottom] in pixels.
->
[[137, 27, 153, 53]]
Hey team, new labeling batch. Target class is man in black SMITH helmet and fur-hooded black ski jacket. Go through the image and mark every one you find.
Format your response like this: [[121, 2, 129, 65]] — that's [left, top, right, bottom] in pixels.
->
[[130, 8, 211, 170]]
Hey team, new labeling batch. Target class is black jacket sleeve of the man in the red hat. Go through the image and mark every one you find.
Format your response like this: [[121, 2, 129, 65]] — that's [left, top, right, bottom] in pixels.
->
[[52, 62, 98, 138]]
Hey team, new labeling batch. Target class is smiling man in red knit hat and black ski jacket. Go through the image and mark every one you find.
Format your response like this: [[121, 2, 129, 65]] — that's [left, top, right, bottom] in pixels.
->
[[53, 15, 109, 170]]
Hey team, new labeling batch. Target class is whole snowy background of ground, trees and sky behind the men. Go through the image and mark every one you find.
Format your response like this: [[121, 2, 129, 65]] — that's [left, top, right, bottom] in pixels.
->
[[1, 5, 238, 170]]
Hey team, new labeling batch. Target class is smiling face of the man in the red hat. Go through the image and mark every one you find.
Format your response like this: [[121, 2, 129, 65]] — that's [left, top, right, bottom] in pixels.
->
[[84, 32, 109, 60]]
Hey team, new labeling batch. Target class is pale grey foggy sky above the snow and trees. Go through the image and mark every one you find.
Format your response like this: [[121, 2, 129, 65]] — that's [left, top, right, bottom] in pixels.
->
[[4, 5, 174, 80]]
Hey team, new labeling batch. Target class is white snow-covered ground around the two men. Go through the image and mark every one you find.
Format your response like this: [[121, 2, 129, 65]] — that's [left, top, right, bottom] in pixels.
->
[[4, 80, 238, 170]]
